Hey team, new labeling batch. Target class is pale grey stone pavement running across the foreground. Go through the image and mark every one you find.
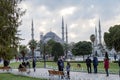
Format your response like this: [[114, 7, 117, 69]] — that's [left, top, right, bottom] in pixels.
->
[[0, 68, 120, 80]]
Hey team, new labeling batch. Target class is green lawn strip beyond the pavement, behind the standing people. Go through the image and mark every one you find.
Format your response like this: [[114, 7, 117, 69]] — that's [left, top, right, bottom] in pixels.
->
[[0, 62, 119, 74]]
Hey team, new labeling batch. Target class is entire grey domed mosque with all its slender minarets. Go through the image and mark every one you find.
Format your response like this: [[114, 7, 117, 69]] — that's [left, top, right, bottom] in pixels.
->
[[31, 17, 116, 57]]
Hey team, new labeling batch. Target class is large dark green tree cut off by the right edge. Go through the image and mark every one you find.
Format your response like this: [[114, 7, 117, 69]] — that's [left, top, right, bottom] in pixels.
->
[[104, 25, 120, 52]]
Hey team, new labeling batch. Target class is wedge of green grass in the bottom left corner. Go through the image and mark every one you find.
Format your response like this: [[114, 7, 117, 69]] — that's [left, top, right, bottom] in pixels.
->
[[0, 73, 47, 80]]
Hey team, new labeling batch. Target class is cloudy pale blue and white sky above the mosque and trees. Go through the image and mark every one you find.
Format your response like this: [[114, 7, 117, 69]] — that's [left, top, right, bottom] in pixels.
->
[[19, 0, 120, 44]]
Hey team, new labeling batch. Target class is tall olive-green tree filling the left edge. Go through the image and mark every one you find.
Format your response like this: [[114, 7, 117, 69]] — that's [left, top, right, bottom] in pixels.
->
[[0, 0, 25, 60]]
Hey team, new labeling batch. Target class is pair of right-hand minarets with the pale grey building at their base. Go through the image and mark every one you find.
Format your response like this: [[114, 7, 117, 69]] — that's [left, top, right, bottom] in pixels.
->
[[92, 20, 116, 56]]
